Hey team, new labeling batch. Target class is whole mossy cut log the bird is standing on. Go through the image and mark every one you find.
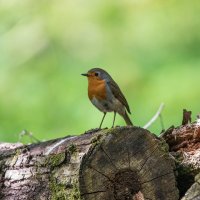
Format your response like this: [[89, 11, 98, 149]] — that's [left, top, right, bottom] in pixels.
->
[[0, 127, 179, 200]]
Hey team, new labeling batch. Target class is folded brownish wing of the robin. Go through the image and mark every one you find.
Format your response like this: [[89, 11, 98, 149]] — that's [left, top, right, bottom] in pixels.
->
[[108, 80, 131, 114]]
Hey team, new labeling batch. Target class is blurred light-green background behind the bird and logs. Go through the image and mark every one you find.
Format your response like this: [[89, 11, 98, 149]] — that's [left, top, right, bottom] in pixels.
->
[[0, 0, 200, 142]]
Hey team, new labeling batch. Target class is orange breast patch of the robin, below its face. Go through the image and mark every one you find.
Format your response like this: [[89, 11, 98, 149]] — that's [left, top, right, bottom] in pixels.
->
[[88, 77, 106, 100]]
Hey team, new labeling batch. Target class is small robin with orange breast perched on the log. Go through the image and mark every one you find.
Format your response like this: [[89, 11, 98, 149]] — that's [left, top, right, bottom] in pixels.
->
[[81, 68, 133, 128]]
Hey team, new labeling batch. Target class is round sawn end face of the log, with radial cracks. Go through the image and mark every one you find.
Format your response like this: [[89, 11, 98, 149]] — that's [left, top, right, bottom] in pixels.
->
[[80, 128, 178, 200]]
